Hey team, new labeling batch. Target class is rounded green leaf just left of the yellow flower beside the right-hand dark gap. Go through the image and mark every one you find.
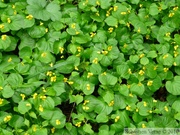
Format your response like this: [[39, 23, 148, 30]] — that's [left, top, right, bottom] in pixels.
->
[[130, 83, 145, 95]]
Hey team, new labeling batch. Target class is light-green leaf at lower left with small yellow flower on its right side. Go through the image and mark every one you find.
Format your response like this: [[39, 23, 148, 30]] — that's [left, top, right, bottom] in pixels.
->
[[18, 100, 32, 114]]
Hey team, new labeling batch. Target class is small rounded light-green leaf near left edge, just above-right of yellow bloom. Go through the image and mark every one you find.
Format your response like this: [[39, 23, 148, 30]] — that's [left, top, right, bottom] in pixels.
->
[[2, 85, 14, 98]]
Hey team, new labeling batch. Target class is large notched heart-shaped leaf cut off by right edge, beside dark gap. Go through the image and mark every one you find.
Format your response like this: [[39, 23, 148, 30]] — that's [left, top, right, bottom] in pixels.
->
[[165, 76, 180, 95]]
